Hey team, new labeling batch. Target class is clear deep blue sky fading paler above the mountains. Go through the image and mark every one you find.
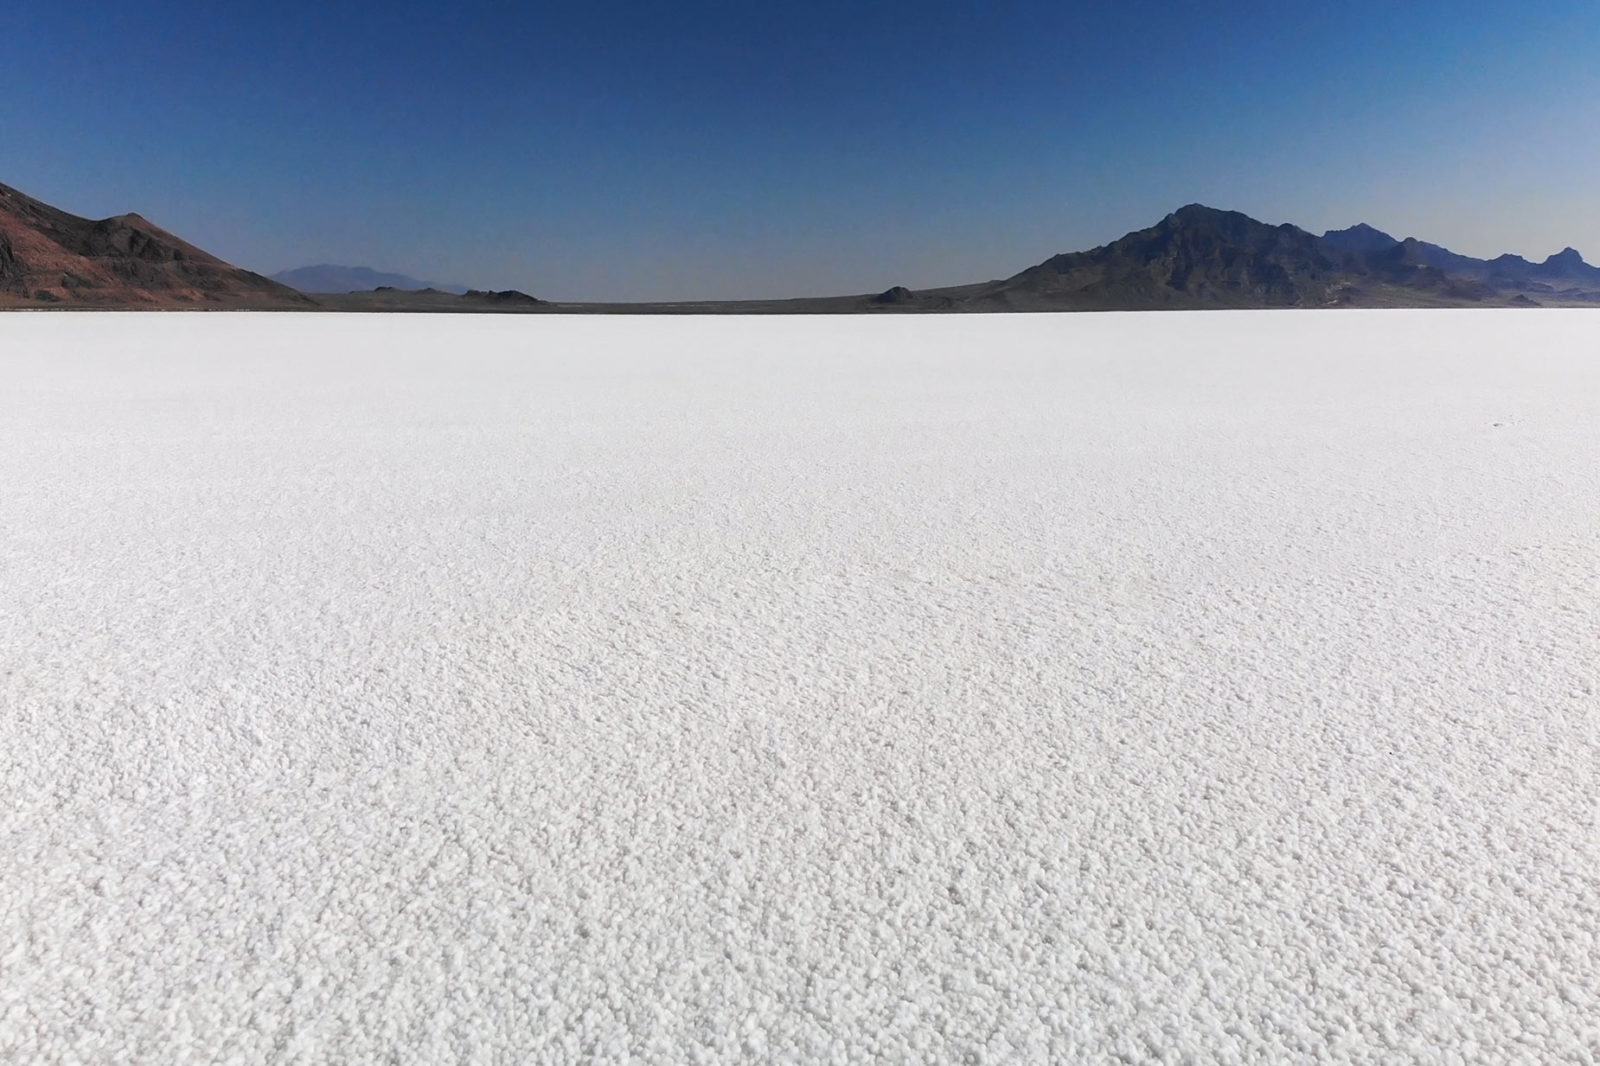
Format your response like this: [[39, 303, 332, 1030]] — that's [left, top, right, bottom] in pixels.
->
[[0, 0, 1600, 299]]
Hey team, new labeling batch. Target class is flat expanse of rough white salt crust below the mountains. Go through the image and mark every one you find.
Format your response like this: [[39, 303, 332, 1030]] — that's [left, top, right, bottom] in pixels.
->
[[0, 312, 1600, 1063]]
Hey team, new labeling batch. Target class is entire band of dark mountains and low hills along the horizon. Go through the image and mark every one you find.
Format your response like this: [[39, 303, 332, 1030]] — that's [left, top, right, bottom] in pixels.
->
[[0, 178, 1600, 314]]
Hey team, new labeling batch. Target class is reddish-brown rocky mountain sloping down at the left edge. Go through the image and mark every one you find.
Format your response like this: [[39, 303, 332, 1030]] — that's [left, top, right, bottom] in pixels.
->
[[0, 186, 315, 309]]
